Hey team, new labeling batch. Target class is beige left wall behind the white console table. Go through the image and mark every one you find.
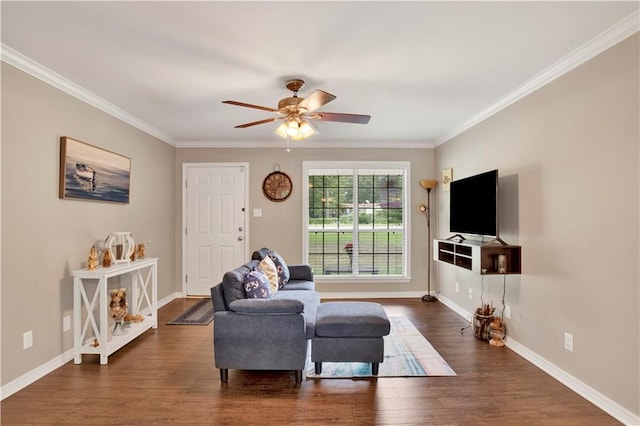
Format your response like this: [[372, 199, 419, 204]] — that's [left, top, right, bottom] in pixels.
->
[[1, 63, 176, 385]]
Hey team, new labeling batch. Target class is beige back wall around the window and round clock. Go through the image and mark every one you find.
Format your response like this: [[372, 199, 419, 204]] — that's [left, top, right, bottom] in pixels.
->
[[176, 146, 434, 297]]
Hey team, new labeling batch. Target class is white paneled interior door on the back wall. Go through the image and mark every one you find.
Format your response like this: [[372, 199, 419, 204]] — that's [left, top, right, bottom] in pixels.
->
[[183, 164, 248, 296]]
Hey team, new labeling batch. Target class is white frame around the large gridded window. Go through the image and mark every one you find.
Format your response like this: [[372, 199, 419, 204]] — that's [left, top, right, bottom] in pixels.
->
[[302, 161, 412, 283]]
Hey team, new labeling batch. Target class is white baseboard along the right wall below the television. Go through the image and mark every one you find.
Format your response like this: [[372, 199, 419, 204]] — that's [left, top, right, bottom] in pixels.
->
[[438, 295, 640, 425]]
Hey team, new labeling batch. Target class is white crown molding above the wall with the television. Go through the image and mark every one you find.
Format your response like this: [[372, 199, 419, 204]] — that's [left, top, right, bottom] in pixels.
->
[[435, 10, 640, 146]]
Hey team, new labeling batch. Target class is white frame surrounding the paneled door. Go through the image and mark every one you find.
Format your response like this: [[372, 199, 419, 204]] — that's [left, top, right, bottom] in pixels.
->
[[180, 162, 250, 297]]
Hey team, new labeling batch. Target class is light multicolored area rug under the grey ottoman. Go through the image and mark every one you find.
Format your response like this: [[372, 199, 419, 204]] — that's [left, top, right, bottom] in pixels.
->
[[307, 317, 456, 379]]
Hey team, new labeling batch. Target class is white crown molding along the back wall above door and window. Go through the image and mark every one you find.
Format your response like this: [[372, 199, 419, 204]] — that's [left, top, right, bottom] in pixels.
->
[[175, 139, 434, 149]]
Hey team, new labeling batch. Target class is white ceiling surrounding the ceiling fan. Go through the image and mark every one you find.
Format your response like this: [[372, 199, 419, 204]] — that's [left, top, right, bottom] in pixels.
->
[[1, 1, 638, 146]]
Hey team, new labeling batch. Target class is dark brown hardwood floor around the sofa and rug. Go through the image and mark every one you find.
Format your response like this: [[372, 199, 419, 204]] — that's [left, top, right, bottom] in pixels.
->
[[0, 299, 619, 425]]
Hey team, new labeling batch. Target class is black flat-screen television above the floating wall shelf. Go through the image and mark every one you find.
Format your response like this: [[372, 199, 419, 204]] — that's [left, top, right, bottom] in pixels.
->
[[449, 170, 498, 237]]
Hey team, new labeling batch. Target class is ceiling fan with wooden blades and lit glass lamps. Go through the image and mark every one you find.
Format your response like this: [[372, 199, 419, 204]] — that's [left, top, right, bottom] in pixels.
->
[[222, 79, 371, 140]]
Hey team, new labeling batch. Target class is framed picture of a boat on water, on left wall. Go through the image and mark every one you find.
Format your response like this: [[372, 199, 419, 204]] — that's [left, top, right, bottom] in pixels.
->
[[59, 136, 131, 204]]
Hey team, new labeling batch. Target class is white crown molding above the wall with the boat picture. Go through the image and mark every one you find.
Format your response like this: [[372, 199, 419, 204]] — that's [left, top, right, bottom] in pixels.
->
[[0, 43, 176, 146]]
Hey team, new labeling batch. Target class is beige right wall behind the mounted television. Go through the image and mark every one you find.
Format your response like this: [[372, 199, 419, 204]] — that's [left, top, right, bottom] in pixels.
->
[[436, 34, 640, 415]]
